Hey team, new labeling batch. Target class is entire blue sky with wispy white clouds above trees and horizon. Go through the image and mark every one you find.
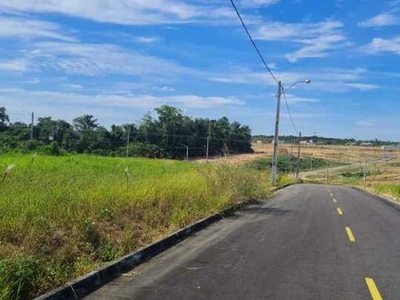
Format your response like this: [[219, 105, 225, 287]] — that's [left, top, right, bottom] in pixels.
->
[[0, 0, 400, 141]]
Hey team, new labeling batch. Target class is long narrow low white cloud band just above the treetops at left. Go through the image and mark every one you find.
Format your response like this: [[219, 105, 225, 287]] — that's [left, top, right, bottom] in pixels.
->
[[0, 89, 244, 109]]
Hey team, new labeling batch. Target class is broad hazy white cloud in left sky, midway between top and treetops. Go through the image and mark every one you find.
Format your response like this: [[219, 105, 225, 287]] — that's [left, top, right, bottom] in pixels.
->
[[13, 42, 196, 80]]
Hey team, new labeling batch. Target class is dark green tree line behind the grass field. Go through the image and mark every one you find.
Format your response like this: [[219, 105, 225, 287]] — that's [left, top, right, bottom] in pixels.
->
[[0, 105, 252, 159]]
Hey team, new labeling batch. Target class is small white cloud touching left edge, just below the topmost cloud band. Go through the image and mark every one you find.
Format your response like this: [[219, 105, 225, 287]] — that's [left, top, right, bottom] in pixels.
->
[[0, 16, 74, 41]]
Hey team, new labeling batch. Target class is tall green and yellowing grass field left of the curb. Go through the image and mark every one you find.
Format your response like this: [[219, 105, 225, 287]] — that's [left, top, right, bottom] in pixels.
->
[[0, 154, 287, 299]]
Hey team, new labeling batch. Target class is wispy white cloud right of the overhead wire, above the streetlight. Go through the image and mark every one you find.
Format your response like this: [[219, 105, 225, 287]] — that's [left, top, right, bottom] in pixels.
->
[[255, 20, 348, 62]]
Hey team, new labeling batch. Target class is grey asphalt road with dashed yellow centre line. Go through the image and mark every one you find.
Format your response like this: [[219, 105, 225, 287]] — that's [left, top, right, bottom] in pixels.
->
[[87, 185, 400, 300]]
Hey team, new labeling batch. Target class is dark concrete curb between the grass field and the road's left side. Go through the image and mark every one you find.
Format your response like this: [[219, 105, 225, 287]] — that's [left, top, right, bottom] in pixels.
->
[[35, 184, 292, 300]]
